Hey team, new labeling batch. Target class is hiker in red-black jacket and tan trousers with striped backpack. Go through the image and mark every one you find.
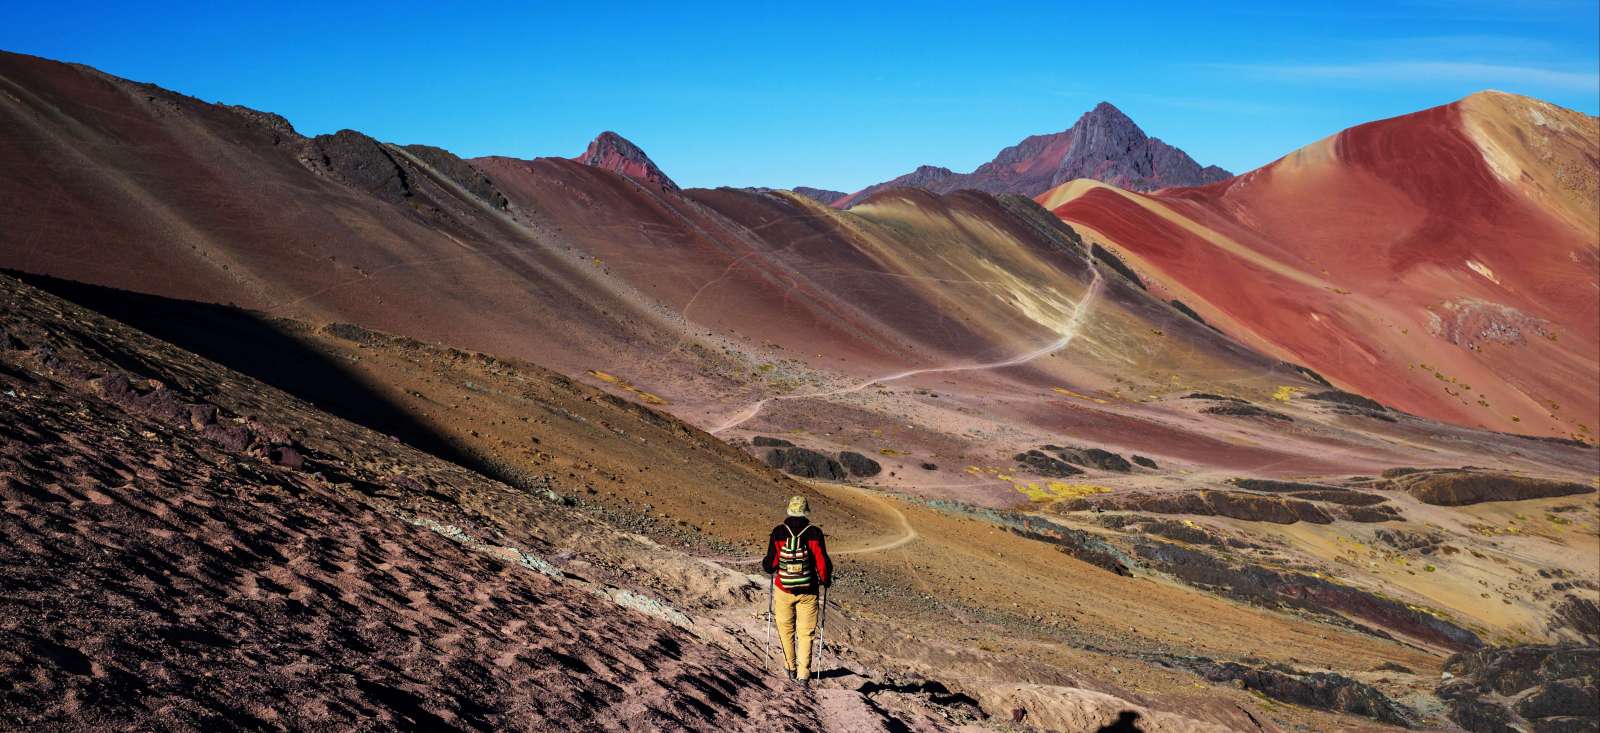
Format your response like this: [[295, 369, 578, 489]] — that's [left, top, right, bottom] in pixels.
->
[[762, 496, 834, 687]]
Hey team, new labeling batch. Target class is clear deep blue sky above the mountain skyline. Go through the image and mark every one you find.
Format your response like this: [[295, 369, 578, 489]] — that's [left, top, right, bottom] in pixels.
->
[[0, 0, 1600, 190]]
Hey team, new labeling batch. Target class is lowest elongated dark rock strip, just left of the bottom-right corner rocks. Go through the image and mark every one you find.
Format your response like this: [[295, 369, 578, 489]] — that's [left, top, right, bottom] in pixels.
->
[[1200, 663, 1414, 728]]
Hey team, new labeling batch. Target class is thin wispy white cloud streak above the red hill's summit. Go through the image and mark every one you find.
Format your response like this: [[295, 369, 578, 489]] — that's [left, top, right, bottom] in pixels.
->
[[1205, 61, 1600, 91]]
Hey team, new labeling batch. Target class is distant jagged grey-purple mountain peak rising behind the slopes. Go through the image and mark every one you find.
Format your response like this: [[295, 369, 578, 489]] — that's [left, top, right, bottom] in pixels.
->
[[834, 102, 1232, 208]]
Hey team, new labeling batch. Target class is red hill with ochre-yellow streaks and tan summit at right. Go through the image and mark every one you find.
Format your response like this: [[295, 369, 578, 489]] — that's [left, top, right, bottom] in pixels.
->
[[1040, 91, 1600, 442]]
